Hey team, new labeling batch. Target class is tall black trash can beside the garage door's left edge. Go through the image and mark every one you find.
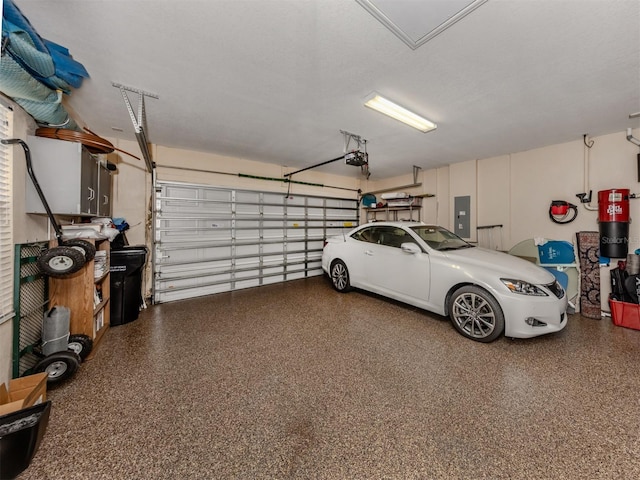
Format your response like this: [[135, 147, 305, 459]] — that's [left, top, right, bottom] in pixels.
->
[[110, 245, 147, 326]]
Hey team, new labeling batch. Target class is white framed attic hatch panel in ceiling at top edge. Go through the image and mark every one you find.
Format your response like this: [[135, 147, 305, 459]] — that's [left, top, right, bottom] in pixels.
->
[[356, 0, 487, 50]]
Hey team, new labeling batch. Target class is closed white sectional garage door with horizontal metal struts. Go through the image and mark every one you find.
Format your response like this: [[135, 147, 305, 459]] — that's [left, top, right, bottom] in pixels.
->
[[153, 182, 358, 303]]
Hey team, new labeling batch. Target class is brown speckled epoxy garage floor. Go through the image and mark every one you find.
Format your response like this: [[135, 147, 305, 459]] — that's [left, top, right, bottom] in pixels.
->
[[19, 277, 640, 479]]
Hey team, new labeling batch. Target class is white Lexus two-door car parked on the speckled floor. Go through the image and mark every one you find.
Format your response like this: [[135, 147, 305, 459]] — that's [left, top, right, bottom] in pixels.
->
[[322, 222, 567, 342]]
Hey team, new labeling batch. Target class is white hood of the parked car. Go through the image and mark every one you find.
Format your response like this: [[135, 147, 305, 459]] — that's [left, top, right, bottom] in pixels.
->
[[440, 247, 555, 285]]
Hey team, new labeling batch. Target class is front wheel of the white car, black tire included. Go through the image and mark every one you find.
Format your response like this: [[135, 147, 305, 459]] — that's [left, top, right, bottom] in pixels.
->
[[449, 285, 504, 343]]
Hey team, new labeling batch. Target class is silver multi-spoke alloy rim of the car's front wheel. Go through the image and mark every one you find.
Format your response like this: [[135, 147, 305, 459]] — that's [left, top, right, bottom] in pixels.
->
[[451, 292, 496, 339]]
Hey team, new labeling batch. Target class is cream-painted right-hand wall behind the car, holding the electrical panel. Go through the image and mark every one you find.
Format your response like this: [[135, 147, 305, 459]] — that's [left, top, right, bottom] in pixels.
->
[[440, 131, 640, 251]]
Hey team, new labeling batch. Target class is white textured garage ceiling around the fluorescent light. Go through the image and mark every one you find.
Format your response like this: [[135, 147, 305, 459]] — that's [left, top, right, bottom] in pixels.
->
[[15, 0, 640, 180]]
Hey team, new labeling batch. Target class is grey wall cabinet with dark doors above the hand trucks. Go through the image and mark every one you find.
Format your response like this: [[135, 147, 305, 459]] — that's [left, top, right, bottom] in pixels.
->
[[25, 136, 111, 217]]
